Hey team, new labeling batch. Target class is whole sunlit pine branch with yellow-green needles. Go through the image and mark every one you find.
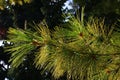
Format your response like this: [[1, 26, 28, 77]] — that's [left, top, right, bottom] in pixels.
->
[[7, 16, 120, 80]]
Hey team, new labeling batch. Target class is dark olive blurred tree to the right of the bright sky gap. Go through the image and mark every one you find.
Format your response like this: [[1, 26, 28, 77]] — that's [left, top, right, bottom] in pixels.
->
[[73, 0, 120, 24]]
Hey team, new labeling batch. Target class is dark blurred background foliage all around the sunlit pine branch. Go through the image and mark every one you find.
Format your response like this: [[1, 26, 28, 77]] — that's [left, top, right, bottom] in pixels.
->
[[0, 0, 120, 80]]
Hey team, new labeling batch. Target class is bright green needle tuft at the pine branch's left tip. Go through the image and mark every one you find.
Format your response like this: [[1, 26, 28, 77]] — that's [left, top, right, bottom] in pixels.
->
[[7, 28, 38, 67]]
